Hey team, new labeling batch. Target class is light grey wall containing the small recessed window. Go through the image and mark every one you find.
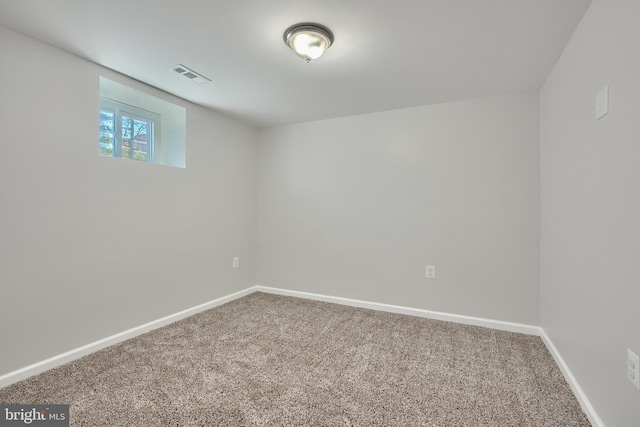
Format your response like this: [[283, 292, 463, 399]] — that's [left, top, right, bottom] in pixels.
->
[[0, 27, 257, 375]]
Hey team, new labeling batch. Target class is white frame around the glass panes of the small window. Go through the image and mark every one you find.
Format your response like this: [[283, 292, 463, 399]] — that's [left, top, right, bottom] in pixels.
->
[[100, 97, 161, 163]]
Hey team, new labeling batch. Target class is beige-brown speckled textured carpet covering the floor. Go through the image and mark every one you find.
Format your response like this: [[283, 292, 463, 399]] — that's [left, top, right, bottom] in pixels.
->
[[0, 293, 590, 427]]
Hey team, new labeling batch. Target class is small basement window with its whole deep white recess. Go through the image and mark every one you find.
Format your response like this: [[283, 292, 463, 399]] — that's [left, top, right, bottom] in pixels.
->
[[98, 77, 186, 168]]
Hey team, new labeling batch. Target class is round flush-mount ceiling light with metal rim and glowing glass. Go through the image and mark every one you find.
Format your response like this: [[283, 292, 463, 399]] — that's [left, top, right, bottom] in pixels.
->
[[283, 22, 333, 62]]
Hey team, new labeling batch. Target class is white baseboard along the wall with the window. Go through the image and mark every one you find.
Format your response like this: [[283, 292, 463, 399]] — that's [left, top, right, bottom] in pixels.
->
[[0, 286, 256, 388]]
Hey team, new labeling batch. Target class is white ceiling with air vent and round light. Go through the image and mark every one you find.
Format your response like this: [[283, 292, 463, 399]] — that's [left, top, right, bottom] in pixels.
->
[[0, 0, 591, 127]]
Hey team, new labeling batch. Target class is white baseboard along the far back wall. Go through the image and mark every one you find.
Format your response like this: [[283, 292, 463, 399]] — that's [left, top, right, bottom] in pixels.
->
[[255, 286, 540, 336]]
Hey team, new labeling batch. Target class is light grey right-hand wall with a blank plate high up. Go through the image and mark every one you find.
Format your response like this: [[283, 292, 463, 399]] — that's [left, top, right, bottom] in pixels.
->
[[541, 0, 640, 427]]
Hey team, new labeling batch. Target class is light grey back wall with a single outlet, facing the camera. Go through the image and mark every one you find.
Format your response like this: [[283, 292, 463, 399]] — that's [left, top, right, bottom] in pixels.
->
[[258, 92, 539, 325]]
